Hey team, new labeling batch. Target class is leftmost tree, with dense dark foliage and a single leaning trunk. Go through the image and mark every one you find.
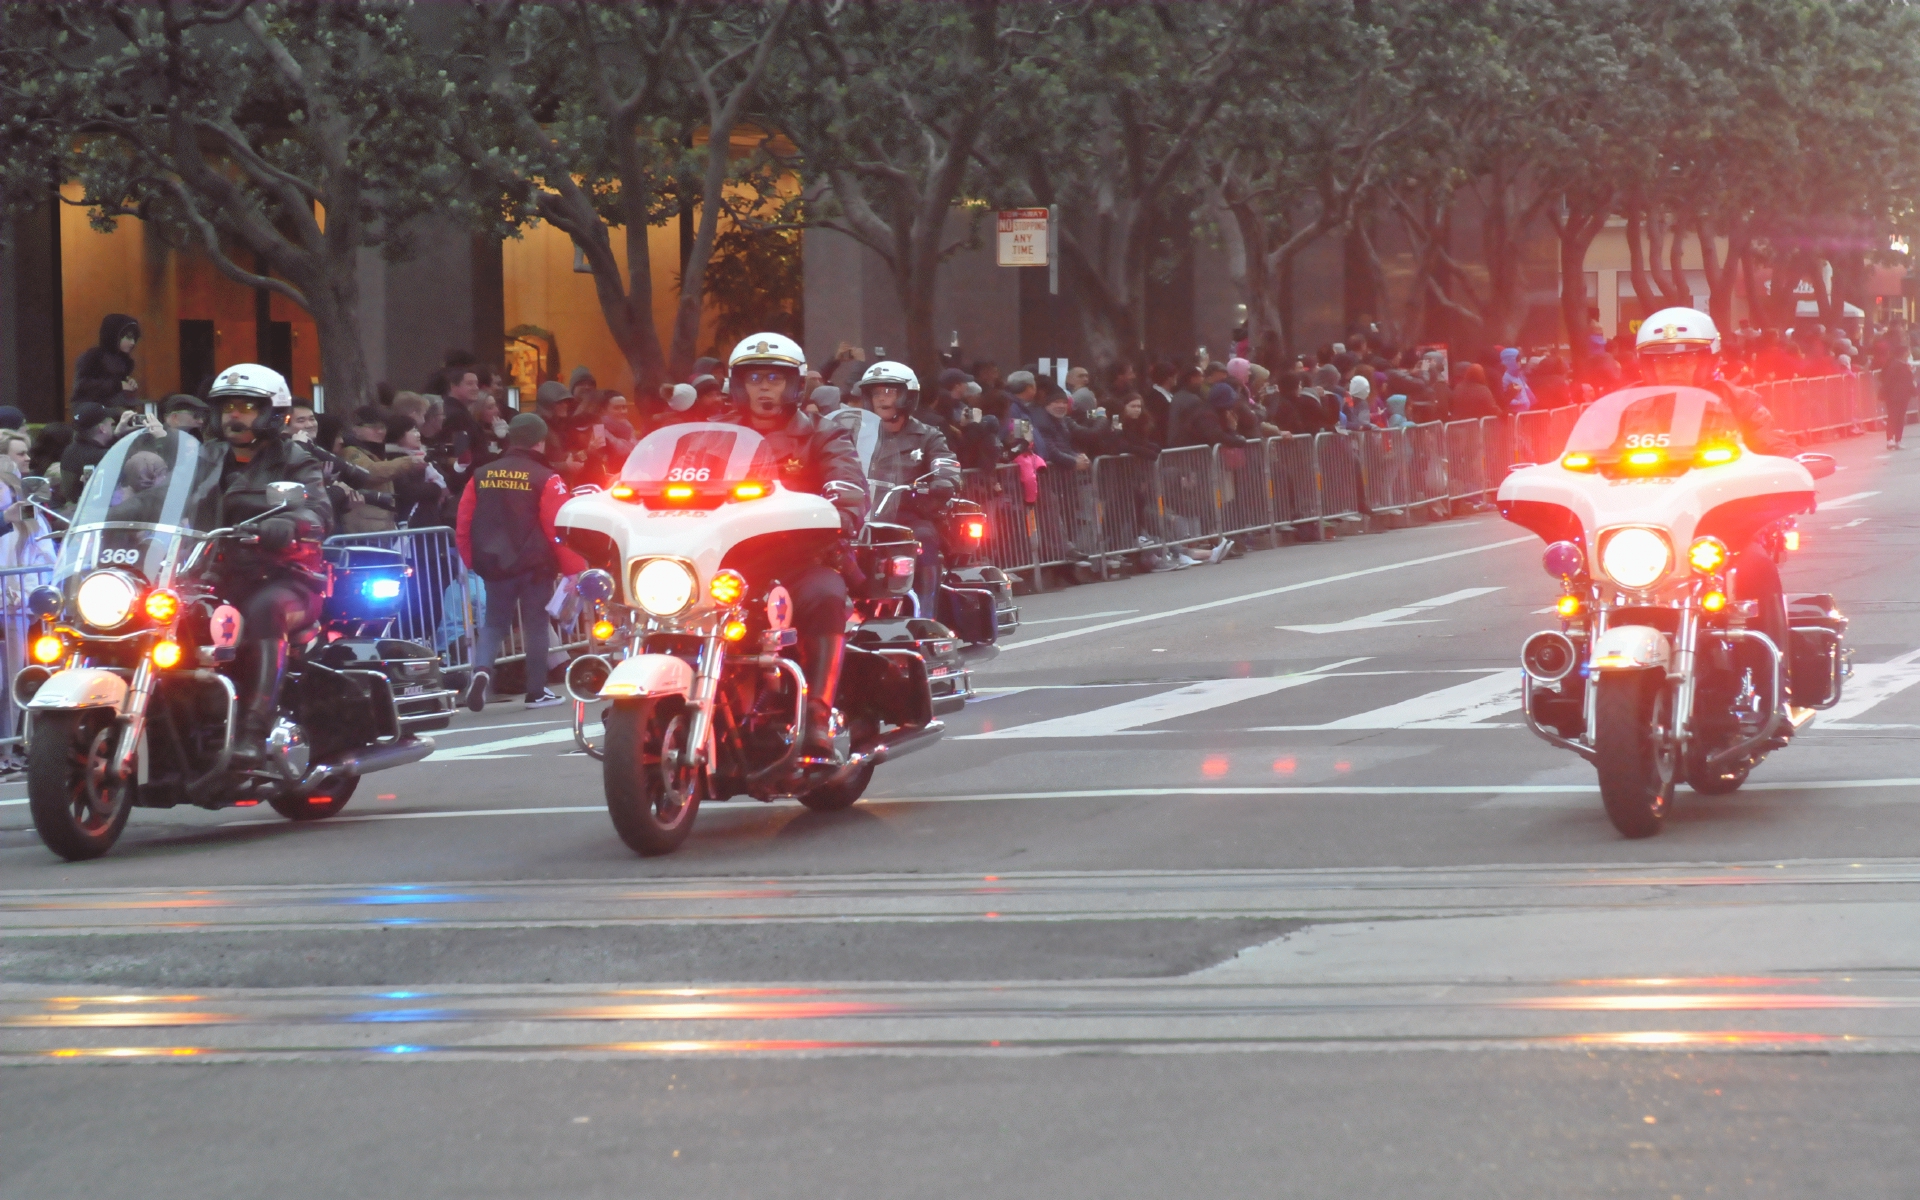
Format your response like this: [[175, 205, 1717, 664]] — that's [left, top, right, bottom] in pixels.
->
[[4, 0, 463, 403]]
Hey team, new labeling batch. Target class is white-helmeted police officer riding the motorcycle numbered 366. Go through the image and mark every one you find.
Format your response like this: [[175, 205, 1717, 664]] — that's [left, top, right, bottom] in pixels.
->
[[724, 334, 866, 760]]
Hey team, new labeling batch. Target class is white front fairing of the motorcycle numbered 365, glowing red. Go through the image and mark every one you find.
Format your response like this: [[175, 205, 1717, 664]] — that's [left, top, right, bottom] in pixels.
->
[[1498, 388, 1814, 570]]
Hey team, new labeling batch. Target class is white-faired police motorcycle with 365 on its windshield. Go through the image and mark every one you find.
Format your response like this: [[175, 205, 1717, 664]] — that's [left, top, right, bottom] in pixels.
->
[[1498, 386, 1847, 837]]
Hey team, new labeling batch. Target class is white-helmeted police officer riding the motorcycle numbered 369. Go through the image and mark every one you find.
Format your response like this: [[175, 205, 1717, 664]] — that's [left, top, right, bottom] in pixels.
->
[[207, 363, 334, 766]]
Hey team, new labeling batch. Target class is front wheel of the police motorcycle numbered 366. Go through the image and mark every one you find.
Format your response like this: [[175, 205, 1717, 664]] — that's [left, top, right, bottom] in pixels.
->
[[601, 699, 705, 858]]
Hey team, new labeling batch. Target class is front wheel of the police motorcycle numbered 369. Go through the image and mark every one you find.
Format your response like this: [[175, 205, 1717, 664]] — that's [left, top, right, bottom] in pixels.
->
[[27, 708, 132, 862]]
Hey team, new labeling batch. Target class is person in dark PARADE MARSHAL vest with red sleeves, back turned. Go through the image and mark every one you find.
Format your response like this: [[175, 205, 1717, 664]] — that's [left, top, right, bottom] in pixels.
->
[[455, 413, 588, 712]]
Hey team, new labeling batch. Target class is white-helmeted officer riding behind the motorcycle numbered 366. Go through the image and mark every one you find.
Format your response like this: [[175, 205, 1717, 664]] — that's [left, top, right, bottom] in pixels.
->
[[856, 361, 960, 616]]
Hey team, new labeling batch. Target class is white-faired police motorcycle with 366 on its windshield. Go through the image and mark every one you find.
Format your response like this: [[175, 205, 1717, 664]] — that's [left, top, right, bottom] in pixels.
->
[[555, 422, 943, 854]]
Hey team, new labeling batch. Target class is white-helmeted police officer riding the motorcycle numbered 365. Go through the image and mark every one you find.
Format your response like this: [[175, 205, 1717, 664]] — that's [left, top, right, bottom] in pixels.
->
[[1634, 307, 1795, 693]]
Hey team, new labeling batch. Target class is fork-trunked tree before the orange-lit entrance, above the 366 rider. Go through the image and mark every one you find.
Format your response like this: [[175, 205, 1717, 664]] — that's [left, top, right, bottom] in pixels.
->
[[453, 0, 789, 392]]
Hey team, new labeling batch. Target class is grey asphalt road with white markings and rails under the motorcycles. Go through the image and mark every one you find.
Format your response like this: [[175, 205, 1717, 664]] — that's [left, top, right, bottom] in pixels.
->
[[0, 426, 1920, 1200]]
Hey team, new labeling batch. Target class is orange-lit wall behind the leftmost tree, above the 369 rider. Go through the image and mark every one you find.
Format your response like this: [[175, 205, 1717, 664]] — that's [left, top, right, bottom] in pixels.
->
[[60, 184, 321, 399]]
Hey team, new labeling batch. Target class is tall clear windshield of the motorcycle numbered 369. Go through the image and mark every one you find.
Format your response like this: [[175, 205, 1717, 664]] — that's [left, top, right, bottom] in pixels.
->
[[54, 430, 221, 589]]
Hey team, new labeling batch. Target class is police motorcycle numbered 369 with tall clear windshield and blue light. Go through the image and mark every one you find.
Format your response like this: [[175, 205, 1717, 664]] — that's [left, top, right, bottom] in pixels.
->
[[13, 432, 434, 860]]
